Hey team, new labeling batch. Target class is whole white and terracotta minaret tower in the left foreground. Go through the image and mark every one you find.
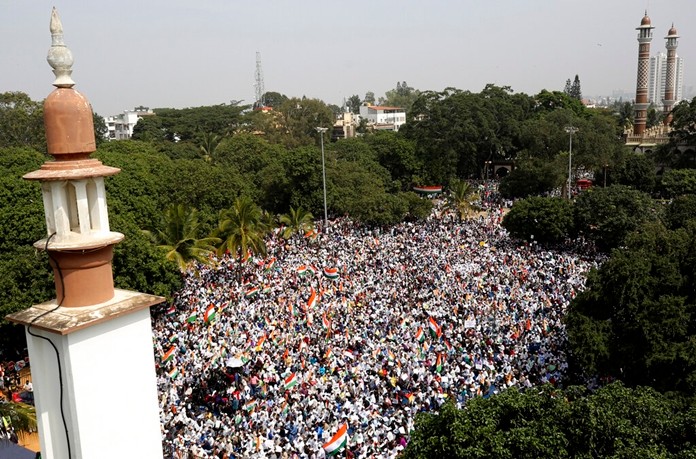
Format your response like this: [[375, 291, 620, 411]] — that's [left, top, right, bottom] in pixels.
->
[[7, 8, 164, 459]]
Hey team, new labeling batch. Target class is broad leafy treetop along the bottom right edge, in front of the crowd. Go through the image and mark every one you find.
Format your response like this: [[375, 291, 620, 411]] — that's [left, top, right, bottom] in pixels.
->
[[401, 383, 696, 459]]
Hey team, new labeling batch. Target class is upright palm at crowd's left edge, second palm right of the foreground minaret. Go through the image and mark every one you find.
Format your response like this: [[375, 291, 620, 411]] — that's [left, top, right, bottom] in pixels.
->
[[216, 196, 266, 264]]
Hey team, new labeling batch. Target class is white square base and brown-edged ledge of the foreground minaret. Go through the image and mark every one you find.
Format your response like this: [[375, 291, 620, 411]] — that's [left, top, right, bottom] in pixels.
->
[[16, 290, 163, 459]]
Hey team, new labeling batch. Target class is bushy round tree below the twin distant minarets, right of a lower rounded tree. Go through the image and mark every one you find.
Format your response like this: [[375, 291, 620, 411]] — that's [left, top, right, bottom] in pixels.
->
[[575, 185, 658, 251]]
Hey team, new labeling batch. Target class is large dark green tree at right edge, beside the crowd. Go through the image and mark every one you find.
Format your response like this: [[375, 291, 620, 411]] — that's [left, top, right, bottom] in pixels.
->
[[566, 222, 696, 397]]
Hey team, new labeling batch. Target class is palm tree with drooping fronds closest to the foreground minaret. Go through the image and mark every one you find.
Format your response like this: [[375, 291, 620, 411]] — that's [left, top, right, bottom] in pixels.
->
[[143, 204, 220, 271]]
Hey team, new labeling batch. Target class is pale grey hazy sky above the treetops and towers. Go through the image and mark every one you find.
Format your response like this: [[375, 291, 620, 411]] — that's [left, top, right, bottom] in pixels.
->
[[0, 0, 696, 116]]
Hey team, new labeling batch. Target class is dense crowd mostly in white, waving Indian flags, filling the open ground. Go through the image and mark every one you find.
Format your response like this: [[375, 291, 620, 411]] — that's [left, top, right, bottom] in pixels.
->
[[154, 199, 597, 458]]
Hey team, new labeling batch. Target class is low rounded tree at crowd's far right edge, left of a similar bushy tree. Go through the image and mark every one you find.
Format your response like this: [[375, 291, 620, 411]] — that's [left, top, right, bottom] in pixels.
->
[[503, 196, 575, 244]]
